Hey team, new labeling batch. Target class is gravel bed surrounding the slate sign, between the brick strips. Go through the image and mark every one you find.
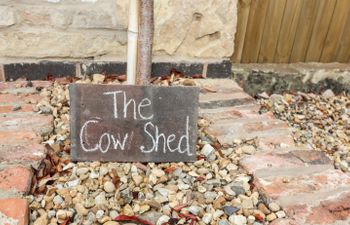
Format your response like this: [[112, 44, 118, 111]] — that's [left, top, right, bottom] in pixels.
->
[[27, 75, 285, 225]]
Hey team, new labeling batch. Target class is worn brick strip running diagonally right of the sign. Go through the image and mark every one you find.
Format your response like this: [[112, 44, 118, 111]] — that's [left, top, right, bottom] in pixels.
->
[[197, 80, 350, 225]]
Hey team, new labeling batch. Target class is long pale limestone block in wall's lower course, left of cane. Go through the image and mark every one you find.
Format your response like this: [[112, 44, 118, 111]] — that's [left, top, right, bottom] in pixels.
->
[[0, 30, 126, 58]]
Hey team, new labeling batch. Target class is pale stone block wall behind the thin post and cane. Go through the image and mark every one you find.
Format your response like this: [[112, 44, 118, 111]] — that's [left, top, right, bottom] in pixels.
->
[[0, 0, 237, 63]]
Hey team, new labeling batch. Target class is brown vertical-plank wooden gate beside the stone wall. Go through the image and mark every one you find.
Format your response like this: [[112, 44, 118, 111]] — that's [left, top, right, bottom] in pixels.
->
[[232, 0, 350, 63]]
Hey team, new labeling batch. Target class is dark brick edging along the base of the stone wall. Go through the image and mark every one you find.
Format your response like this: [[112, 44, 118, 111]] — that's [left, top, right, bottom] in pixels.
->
[[0, 60, 232, 81]]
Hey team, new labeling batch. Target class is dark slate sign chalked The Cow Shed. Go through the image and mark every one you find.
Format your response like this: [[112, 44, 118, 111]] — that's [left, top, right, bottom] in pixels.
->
[[69, 84, 199, 162]]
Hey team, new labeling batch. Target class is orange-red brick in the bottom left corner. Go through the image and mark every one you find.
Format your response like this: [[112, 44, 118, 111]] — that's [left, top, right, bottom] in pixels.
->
[[0, 198, 28, 225]]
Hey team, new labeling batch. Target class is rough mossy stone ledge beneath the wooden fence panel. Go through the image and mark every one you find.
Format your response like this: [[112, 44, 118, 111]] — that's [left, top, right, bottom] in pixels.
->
[[232, 63, 350, 95]]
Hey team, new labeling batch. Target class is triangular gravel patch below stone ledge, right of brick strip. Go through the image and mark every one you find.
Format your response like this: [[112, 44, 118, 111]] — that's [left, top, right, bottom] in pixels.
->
[[258, 90, 350, 172]]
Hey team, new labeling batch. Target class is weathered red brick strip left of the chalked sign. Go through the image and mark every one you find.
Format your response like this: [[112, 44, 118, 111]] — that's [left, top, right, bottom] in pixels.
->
[[0, 81, 52, 225]]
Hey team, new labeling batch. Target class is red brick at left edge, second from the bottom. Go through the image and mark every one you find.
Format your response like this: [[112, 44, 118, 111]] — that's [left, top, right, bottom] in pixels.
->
[[0, 167, 32, 194]]
